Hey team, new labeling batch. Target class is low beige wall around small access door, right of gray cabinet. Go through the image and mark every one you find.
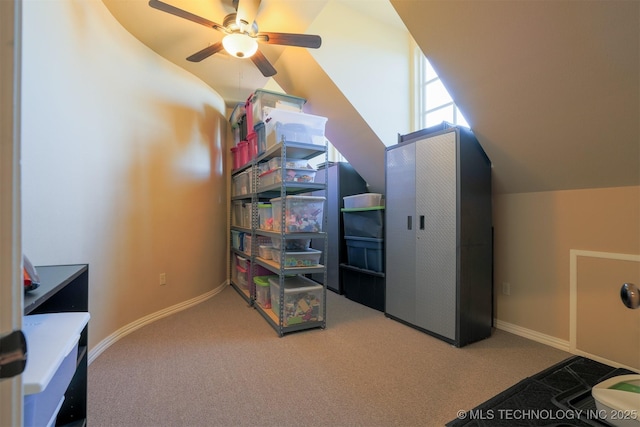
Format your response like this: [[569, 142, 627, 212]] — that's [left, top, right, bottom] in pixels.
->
[[494, 186, 640, 342]]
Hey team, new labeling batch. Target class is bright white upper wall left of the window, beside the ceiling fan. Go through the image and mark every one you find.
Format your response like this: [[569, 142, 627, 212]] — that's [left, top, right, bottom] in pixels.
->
[[308, 1, 411, 146]]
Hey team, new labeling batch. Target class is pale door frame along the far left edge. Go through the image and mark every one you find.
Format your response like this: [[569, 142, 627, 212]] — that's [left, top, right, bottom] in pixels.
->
[[0, 0, 24, 426]]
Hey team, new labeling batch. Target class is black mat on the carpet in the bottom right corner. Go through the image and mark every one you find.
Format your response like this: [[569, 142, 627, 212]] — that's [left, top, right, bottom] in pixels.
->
[[447, 356, 636, 427]]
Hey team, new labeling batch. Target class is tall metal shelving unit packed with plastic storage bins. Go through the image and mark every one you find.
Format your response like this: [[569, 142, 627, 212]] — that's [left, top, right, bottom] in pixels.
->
[[230, 90, 327, 335]]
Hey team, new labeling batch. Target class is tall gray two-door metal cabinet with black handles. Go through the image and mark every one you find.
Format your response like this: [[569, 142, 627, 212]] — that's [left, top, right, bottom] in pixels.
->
[[385, 127, 492, 346]]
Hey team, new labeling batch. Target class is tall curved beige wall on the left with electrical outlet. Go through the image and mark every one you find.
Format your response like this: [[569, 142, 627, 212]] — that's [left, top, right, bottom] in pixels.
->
[[22, 0, 227, 349]]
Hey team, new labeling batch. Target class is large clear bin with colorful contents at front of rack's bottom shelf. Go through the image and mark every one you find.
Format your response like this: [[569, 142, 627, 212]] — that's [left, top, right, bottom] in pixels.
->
[[269, 276, 323, 326]]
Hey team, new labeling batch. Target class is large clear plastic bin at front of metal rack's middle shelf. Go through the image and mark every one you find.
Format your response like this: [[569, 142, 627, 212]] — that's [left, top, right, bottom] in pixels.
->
[[271, 196, 325, 233]]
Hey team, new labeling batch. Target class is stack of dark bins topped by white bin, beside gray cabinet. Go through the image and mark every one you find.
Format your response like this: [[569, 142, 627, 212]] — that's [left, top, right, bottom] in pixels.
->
[[340, 193, 385, 311]]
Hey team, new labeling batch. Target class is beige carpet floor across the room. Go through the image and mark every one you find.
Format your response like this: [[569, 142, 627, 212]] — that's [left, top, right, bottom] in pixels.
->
[[87, 288, 571, 427]]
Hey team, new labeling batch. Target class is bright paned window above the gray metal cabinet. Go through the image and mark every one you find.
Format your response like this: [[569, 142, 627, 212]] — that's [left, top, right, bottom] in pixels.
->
[[416, 47, 469, 129]]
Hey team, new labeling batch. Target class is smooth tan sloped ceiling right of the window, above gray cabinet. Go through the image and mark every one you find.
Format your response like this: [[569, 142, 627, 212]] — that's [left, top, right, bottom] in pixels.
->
[[391, 0, 640, 192]]
